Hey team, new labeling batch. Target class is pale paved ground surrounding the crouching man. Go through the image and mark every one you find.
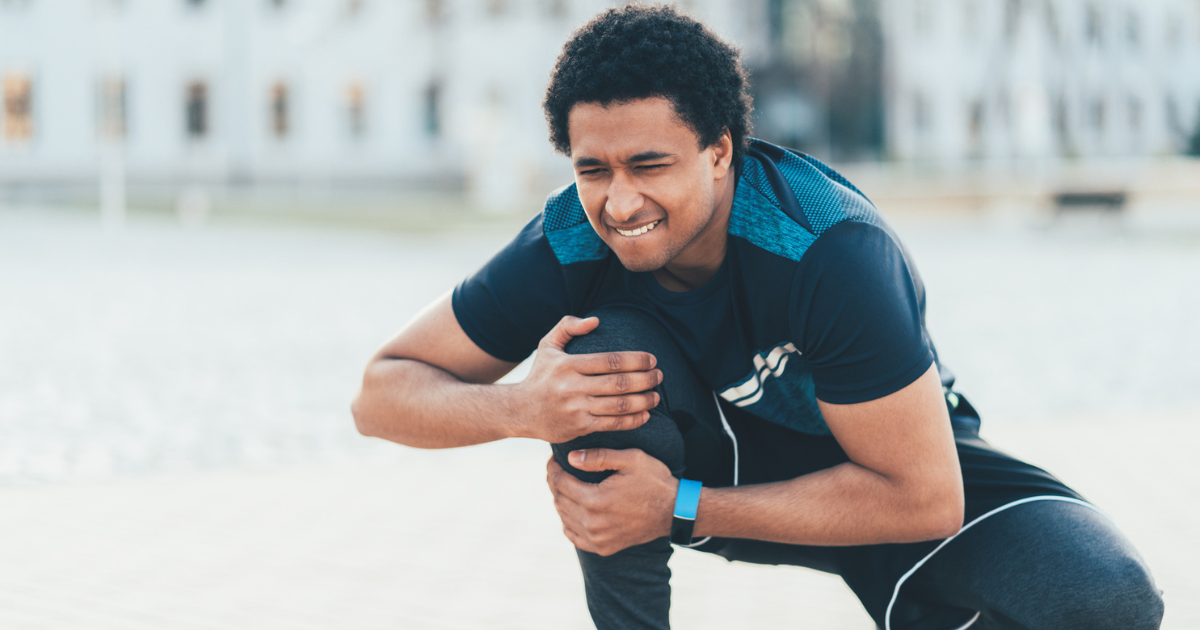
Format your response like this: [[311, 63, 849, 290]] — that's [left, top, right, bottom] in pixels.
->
[[0, 205, 1200, 630]]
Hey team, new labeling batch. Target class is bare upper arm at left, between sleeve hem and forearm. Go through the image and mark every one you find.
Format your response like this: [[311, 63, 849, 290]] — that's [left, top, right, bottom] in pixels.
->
[[372, 293, 517, 383]]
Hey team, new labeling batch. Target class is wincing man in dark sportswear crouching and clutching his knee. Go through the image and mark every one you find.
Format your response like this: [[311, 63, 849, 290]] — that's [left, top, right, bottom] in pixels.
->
[[354, 5, 1163, 630]]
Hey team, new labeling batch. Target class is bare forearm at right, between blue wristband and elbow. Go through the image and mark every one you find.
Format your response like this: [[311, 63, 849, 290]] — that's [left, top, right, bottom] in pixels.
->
[[695, 463, 962, 546]]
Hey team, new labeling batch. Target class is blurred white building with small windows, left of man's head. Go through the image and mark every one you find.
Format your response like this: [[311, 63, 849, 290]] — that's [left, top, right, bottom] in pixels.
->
[[0, 0, 764, 209]]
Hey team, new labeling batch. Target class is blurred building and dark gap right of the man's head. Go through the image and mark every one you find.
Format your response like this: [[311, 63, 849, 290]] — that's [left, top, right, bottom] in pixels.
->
[[756, 0, 1200, 161]]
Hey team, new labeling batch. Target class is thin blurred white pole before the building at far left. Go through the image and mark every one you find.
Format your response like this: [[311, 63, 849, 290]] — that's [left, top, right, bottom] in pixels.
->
[[96, 2, 126, 228]]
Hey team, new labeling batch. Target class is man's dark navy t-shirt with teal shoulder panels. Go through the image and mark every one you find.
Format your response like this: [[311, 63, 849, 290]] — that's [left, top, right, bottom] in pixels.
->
[[454, 140, 953, 434]]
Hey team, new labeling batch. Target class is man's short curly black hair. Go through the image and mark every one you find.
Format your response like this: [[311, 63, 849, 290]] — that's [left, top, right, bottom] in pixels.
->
[[542, 2, 752, 163]]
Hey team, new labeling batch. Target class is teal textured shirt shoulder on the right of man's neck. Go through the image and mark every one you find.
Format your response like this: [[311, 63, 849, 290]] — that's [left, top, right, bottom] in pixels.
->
[[730, 139, 882, 262]]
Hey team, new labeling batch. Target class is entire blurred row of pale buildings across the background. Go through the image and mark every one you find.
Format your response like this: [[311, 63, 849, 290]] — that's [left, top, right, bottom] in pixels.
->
[[0, 0, 1200, 209]]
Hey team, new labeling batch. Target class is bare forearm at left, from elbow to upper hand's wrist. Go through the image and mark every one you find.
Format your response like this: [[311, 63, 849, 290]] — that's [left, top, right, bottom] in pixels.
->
[[352, 359, 521, 449]]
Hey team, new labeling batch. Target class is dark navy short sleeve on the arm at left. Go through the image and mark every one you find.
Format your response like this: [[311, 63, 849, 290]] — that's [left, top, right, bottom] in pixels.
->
[[451, 215, 570, 362]]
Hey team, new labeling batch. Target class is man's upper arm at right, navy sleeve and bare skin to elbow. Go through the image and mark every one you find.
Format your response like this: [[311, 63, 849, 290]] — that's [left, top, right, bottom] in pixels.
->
[[793, 222, 959, 482]]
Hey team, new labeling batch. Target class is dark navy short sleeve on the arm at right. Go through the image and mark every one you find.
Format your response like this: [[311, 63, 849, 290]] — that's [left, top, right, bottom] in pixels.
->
[[791, 221, 934, 404]]
